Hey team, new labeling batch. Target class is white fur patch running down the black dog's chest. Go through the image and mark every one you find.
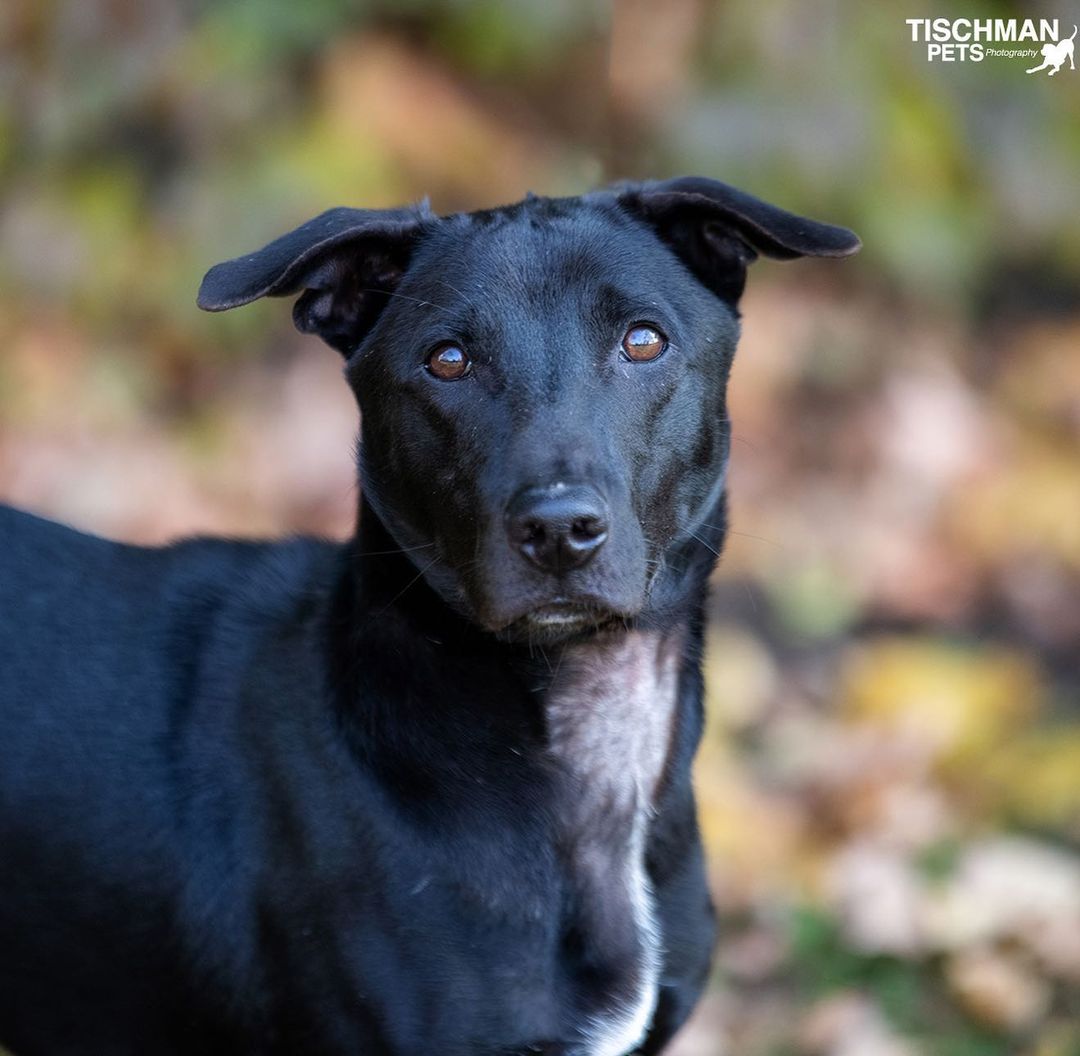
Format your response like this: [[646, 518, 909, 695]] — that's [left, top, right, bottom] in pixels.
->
[[545, 631, 683, 1056]]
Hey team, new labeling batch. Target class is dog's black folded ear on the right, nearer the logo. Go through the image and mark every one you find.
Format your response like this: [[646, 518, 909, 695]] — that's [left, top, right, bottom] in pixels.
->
[[616, 176, 861, 306]]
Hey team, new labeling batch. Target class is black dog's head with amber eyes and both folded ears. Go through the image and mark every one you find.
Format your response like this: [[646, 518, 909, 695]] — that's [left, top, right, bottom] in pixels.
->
[[199, 178, 859, 639]]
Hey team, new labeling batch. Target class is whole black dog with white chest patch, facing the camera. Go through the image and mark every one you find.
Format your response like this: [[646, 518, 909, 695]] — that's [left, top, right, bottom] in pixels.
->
[[0, 178, 859, 1056]]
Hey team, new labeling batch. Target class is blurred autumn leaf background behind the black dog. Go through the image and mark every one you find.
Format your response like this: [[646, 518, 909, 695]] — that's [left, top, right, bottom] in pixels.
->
[[0, 0, 1080, 1056]]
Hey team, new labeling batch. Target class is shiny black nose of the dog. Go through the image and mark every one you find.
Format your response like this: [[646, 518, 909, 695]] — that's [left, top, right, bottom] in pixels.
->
[[507, 484, 608, 573]]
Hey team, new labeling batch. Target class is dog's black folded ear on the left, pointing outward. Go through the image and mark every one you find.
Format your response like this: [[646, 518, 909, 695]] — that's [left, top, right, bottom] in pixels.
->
[[198, 202, 435, 357]]
